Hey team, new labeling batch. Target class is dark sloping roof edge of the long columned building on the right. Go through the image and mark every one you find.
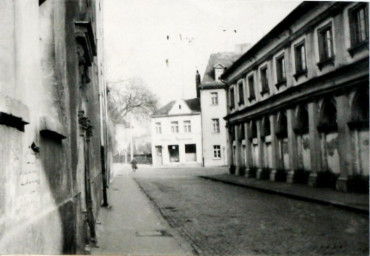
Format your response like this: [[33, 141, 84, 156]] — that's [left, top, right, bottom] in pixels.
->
[[221, 1, 322, 79]]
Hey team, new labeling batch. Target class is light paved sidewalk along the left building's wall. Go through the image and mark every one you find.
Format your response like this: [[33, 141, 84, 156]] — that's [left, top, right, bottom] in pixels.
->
[[91, 167, 191, 255]]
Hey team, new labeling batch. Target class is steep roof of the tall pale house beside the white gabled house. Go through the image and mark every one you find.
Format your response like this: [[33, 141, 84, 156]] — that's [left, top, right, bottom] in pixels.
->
[[202, 52, 241, 86]]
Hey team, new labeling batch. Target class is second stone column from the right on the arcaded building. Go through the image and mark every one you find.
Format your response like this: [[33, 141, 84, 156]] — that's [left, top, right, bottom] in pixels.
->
[[308, 102, 321, 187]]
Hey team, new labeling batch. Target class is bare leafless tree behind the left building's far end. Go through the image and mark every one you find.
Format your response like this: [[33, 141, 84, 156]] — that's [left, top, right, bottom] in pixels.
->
[[108, 77, 158, 123]]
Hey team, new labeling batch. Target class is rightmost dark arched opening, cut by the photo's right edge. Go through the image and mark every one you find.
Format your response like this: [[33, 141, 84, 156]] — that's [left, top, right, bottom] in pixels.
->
[[348, 89, 369, 129]]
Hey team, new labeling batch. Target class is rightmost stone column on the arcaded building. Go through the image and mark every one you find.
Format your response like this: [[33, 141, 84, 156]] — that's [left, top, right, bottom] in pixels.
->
[[336, 95, 354, 191]]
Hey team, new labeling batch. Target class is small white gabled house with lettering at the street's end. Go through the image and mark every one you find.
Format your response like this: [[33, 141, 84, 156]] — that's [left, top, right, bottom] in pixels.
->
[[151, 98, 202, 166]]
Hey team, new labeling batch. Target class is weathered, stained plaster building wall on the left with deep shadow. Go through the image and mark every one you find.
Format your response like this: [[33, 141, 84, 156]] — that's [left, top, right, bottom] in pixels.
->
[[0, 0, 109, 254]]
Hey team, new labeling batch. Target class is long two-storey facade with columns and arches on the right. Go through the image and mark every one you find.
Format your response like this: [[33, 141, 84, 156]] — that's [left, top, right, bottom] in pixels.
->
[[222, 2, 369, 191]]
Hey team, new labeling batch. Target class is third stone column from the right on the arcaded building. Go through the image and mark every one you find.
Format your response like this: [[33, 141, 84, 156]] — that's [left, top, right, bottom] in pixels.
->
[[287, 108, 298, 183]]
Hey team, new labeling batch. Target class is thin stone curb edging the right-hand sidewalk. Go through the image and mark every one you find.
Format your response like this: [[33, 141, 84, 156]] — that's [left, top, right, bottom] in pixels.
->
[[198, 176, 369, 214]]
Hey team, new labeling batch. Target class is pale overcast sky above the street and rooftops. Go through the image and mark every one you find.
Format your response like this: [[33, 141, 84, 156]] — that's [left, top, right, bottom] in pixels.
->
[[104, 0, 300, 105]]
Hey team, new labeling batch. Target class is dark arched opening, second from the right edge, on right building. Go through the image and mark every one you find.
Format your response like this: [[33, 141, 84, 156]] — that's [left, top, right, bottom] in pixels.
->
[[317, 99, 338, 133]]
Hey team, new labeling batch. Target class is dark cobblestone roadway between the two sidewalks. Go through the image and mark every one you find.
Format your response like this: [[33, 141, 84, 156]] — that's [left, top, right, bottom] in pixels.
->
[[133, 167, 369, 255]]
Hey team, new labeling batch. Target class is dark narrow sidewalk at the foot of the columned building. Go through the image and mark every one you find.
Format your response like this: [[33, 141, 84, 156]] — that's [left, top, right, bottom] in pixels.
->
[[199, 174, 369, 213]]
